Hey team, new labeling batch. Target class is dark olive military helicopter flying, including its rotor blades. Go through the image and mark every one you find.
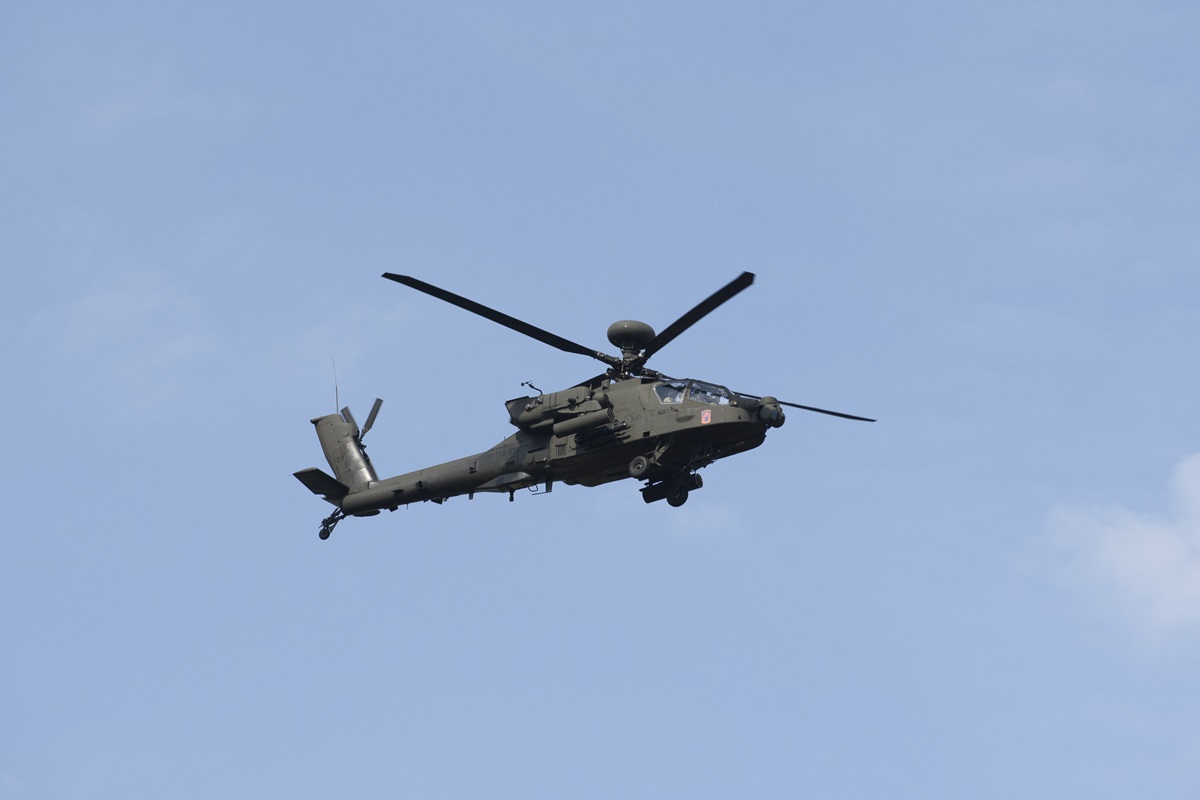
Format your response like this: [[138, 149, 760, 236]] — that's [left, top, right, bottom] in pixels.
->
[[295, 272, 875, 539]]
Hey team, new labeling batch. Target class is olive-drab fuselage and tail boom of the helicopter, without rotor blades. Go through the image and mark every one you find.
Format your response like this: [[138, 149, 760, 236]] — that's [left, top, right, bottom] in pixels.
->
[[301, 378, 784, 527]]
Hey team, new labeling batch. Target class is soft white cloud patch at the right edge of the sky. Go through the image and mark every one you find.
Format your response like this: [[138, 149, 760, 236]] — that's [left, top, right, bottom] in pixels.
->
[[1050, 453, 1200, 634]]
